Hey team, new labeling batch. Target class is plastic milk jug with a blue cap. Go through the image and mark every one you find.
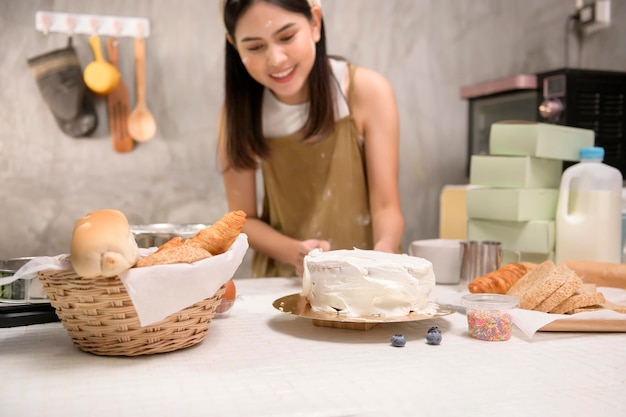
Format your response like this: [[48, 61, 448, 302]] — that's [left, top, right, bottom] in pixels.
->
[[555, 147, 623, 264]]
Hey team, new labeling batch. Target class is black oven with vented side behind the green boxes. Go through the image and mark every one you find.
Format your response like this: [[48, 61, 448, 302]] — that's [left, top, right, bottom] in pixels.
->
[[461, 68, 626, 178]]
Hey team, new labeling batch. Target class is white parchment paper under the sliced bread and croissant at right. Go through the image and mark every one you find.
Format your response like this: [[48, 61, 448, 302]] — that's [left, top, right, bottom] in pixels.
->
[[434, 287, 626, 337]]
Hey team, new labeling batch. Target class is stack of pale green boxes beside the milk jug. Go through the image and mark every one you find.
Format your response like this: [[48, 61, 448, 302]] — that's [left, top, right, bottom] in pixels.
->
[[467, 121, 594, 262]]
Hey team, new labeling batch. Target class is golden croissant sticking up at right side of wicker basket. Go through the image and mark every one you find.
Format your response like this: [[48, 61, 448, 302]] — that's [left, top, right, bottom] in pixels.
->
[[185, 210, 246, 255]]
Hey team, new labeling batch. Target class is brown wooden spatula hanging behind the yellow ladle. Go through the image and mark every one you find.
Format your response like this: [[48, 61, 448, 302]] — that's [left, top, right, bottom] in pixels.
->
[[106, 38, 135, 152]]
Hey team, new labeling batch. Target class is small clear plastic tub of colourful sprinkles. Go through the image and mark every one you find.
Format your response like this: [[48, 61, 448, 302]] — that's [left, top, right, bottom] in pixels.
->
[[461, 293, 519, 342]]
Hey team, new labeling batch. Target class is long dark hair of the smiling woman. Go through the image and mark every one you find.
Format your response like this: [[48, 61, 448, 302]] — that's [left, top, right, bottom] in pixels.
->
[[224, 0, 335, 169]]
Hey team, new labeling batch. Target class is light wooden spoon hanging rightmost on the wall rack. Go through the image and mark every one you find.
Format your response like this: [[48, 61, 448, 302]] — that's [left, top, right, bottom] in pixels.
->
[[128, 37, 156, 142]]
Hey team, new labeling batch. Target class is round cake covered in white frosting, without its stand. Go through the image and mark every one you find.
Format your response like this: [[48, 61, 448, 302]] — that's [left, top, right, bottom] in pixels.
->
[[301, 249, 435, 317]]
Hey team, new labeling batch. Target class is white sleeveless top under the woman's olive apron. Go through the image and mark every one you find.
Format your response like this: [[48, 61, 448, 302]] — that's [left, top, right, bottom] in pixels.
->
[[263, 58, 350, 138]]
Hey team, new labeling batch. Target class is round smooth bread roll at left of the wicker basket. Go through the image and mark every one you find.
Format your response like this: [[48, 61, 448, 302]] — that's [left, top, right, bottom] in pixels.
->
[[70, 209, 139, 278]]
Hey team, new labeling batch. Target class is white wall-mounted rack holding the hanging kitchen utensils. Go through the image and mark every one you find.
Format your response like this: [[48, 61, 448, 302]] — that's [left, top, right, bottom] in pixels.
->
[[35, 11, 150, 38]]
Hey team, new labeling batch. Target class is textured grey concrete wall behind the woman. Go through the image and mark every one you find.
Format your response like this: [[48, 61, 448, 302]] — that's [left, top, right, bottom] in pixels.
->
[[0, 0, 626, 276]]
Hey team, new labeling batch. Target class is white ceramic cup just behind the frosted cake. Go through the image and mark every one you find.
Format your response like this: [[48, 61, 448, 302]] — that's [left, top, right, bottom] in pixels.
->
[[409, 239, 461, 284]]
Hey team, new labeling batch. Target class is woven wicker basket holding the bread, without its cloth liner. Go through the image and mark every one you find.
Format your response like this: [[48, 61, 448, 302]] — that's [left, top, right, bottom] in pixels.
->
[[38, 270, 226, 356]]
